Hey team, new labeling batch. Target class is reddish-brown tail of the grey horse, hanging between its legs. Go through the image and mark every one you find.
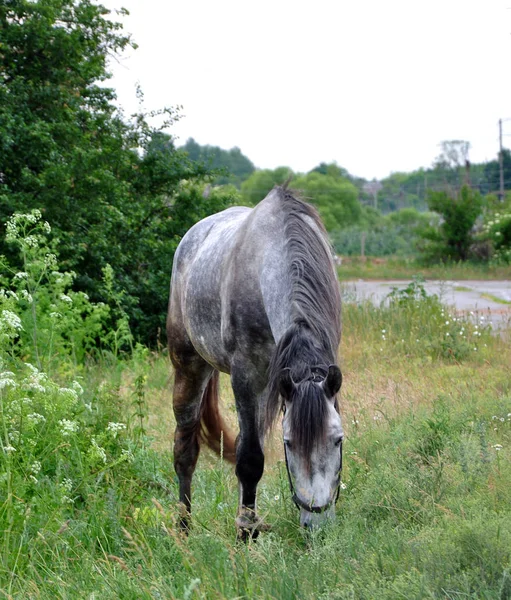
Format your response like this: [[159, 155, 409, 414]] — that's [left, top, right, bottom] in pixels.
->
[[199, 371, 236, 464]]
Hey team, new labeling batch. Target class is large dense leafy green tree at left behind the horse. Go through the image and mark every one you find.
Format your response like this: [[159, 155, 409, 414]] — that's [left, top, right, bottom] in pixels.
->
[[0, 0, 232, 342]]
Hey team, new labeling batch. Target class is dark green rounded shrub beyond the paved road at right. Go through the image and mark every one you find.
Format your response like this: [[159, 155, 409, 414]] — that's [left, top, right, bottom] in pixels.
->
[[420, 185, 482, 262]]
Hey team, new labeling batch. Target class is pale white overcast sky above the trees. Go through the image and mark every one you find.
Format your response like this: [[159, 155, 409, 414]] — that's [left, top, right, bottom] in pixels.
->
[[101, 0, 511, 179]]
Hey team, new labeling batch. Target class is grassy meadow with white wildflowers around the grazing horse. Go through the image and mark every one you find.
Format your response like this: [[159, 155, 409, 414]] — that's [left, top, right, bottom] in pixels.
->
[[0, 213, 511, 600]]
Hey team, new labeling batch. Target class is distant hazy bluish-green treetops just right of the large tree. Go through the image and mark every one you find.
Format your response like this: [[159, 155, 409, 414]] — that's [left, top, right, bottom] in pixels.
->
[[182, 138, 255, 188]]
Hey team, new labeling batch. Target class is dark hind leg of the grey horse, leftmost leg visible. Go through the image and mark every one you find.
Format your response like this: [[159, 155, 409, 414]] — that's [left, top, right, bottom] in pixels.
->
[[173, 357, 213, 531]]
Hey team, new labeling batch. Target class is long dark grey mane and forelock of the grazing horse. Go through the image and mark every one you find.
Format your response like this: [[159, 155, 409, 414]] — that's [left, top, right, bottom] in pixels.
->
[[266, 186, 341, 457]]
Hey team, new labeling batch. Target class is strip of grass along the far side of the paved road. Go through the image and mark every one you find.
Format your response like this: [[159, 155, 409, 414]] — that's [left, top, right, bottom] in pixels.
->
[[338, 257, 511, 281]]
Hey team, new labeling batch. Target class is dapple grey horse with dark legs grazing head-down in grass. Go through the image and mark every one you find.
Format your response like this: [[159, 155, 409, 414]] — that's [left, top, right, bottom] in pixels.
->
[[167, 186, 344, 539]]
